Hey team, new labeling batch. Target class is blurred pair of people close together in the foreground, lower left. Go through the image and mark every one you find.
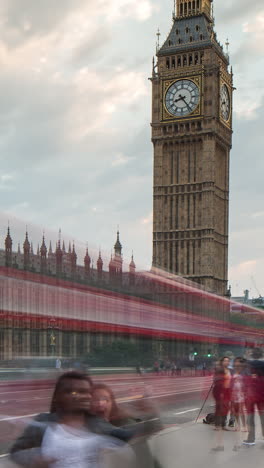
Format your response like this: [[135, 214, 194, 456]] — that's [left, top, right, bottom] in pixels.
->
[[10, 371, 160, 468]]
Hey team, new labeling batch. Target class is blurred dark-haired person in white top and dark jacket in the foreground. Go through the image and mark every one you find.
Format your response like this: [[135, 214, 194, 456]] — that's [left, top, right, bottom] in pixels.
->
[[11, 371, 132, 468]]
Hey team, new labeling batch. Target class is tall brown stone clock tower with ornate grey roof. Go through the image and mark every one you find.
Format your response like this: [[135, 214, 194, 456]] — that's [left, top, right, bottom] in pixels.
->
[[151, 0, 233, 295]]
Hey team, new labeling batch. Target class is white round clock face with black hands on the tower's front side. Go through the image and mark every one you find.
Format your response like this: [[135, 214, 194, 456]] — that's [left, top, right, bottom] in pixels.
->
[[165, 80, 200, 117]]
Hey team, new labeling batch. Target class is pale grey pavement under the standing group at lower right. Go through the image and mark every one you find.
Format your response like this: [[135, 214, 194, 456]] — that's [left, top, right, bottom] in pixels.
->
[[0, 415, 264, 468]]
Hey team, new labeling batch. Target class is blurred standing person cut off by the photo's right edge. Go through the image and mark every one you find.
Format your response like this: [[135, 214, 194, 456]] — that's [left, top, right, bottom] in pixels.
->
[[243, 348, 264, 445]]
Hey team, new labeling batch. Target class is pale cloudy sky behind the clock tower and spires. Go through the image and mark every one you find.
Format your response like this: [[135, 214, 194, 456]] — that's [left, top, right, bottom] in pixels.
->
[[0, 0, 264, 296]]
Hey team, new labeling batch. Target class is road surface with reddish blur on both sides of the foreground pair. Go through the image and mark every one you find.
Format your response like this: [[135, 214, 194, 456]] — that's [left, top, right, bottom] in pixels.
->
[[0, 374, 212, 455]]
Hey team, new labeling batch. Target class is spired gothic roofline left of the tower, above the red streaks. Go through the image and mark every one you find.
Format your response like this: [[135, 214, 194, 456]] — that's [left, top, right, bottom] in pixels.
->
[[0, 227, 136, 287]]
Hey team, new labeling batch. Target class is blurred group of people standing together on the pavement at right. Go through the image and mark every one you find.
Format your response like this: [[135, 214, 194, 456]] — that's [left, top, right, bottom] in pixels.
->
[[213, 349, 264, 451]]
